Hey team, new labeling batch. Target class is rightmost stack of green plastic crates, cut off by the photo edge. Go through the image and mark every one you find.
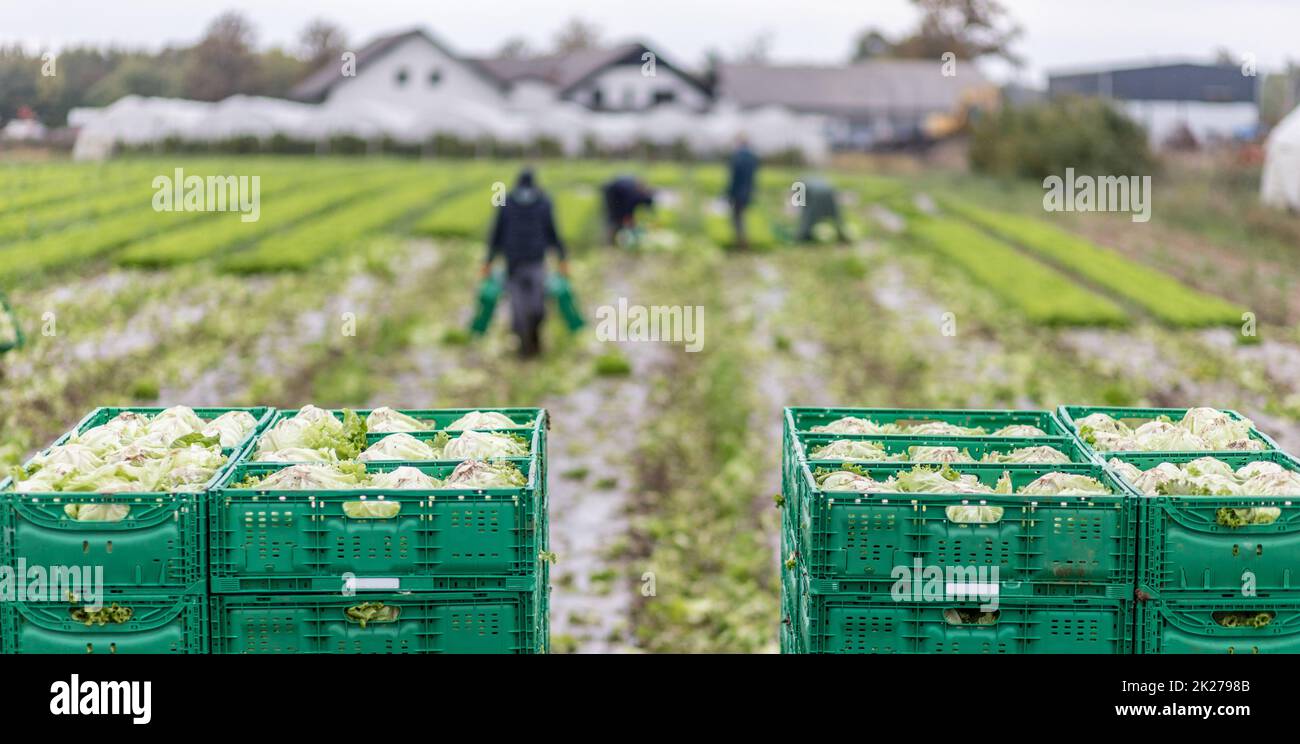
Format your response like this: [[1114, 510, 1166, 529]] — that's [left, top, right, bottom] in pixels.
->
[[1060, 406, 1300, 654]]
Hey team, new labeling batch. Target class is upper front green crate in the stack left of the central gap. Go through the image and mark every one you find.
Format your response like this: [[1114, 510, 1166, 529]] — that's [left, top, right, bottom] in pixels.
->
[[208, 458, 549, 593]]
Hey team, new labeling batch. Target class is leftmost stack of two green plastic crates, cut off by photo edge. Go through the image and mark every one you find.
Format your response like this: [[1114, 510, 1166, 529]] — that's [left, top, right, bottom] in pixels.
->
[[0, 407, 274, 654]]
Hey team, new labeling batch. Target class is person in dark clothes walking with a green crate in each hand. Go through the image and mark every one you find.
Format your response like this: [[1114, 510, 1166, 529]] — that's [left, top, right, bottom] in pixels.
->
[[482, 168, 568, 358]]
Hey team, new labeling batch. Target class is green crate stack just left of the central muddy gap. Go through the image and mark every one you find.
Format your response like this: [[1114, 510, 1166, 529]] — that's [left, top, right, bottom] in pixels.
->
[[209, 408, 550, 653]]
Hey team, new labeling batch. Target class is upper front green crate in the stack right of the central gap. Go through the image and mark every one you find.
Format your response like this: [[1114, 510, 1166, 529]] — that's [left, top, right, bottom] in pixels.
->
[[797, 460, 1138, 598]]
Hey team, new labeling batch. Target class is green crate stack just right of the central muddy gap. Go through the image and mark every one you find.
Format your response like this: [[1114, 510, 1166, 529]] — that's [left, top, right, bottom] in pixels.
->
[[781, 408, 1136, 653]]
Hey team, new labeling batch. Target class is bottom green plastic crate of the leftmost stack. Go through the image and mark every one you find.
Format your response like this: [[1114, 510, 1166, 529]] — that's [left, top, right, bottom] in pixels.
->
[[0, 592, 208, 654]]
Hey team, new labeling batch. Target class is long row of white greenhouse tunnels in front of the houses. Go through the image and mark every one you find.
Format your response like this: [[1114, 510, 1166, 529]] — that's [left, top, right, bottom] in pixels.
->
[[69, 95, 829, 163]]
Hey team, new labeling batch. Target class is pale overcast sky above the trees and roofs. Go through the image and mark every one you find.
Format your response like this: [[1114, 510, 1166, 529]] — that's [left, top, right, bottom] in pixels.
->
[[0, 0, 1300, 83]]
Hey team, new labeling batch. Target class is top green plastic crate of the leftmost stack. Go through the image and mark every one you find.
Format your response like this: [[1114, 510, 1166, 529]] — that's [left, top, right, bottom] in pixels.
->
[[0, 408, 272, 594]]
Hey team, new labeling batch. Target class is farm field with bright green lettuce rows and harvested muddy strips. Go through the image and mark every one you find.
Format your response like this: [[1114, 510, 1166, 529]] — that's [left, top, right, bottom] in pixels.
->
[[0, 157, 1300, 652]]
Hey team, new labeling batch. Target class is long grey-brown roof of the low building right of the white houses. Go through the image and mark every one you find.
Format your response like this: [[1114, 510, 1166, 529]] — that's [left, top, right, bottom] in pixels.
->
[[718, 60, 989, 116]]
